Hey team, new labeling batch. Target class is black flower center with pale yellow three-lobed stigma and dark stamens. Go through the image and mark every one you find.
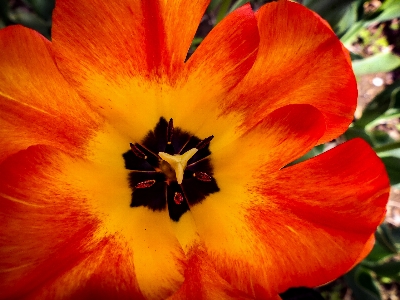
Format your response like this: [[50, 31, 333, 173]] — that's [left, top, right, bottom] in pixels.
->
[[123, 118, 219, 221]]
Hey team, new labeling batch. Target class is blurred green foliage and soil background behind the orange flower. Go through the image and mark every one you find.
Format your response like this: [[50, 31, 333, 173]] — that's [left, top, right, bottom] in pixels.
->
[[0, 0, 400, 300]]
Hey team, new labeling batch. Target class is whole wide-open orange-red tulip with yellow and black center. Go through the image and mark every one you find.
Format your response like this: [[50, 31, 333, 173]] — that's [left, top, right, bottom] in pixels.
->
[[0, 0, 389, 299]]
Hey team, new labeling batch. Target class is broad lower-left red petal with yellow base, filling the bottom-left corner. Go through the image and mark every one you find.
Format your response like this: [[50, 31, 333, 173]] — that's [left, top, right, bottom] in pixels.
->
[[0, 145, 185, 299]]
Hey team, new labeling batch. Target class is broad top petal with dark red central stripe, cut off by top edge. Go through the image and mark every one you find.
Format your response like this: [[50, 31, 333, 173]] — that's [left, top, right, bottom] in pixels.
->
[[52, 0, 209, 138]]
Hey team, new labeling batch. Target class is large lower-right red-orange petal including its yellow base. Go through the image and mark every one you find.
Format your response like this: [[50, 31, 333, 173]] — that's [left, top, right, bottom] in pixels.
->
[[190, 139, 389, 298]]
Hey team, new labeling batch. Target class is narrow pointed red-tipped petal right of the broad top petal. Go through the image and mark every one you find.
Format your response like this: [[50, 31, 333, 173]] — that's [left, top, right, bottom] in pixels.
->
[[170, 5, 259, 137]]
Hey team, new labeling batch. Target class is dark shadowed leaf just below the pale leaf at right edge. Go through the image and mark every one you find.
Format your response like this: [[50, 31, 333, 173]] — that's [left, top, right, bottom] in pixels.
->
[[353, 79, 400, 127]]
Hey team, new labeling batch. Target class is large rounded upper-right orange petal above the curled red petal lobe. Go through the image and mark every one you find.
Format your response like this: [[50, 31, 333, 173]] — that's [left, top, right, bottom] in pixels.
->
[[226, 1, 357, 143]]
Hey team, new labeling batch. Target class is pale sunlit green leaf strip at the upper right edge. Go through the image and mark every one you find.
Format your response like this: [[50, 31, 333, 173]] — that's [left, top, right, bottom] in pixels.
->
[[353, 52, 400, 76]]
